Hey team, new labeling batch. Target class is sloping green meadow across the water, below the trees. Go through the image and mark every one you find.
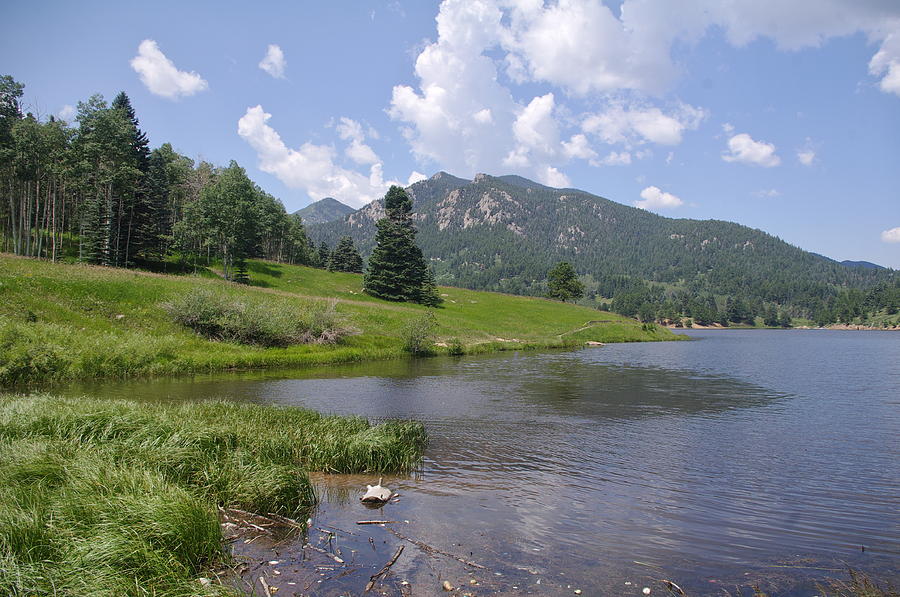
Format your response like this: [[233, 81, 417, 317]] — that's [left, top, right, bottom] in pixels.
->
[[0, 255, 674, 386]]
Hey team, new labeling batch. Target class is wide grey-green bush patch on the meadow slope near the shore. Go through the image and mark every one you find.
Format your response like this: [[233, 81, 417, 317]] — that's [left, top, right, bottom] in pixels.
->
[[163, 290, 349, 348]]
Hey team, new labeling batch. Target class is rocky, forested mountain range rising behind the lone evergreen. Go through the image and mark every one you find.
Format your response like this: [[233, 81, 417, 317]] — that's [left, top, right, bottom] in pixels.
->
[[309, 172, 894, 312]]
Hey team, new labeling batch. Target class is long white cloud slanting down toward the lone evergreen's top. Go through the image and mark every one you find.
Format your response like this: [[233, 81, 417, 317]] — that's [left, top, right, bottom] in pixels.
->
[[238, 106, 400, 207]]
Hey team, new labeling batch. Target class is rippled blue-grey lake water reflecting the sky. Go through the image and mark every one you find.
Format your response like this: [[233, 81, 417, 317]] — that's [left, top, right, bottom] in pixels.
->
[[70, 330, 900, 595]]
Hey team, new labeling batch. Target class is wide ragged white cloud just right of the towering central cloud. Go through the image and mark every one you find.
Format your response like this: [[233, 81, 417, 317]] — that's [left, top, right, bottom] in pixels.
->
[[581, 103, 706, 146]]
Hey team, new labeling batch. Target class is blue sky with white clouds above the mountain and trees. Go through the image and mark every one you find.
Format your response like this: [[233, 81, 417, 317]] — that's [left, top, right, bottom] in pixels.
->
[[0, 0, 900, 268]]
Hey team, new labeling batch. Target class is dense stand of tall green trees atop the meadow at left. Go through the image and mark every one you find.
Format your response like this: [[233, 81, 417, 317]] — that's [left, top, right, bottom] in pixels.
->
[[0, 76, 361, 281]]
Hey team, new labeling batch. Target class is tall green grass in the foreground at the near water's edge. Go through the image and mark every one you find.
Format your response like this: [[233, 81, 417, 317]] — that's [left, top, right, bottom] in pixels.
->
[[0, 395, 425, 596]]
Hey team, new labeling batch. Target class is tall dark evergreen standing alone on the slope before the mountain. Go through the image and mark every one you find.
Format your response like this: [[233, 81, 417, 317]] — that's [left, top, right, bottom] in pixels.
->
[[364, 186, 431, 302]]
